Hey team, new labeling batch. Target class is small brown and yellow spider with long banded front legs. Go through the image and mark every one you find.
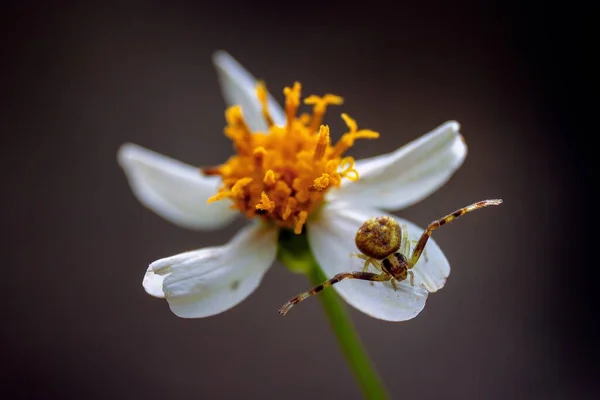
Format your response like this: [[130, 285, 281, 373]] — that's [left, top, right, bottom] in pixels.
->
[[279, 199, 502, 315]]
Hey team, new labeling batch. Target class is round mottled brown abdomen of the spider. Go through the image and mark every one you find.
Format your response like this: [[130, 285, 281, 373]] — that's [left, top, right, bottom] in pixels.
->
[[354, 216, 402, 260]]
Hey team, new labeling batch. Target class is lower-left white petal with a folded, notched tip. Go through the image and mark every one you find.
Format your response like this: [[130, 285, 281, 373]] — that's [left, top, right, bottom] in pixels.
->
[[143, 223, 277, 318]]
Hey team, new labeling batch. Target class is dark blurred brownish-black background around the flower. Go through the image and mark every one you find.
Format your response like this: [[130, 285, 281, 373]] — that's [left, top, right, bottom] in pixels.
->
[[0, 1, 600, 399]]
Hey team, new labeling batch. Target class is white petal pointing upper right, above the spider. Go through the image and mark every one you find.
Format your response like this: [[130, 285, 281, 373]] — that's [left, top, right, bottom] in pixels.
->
[[329, 121, 467, 210]]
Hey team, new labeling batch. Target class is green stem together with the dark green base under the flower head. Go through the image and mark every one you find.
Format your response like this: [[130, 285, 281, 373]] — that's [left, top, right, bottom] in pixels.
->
[[277, 230, 388, 400]]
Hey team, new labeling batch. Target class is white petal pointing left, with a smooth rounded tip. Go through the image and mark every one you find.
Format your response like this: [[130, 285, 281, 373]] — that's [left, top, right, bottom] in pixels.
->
[[117, 143, 237, 229]]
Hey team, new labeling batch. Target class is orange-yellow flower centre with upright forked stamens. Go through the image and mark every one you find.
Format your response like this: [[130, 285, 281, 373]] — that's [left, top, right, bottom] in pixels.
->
[[203, 82, 379, 234]]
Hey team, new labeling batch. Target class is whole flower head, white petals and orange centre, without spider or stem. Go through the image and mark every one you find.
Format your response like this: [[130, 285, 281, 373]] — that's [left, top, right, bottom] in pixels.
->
[[118, 52, 467, 321]]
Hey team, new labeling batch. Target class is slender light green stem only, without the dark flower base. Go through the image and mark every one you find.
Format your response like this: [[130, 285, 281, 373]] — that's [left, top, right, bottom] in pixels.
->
[[308, 262, 388, 399]]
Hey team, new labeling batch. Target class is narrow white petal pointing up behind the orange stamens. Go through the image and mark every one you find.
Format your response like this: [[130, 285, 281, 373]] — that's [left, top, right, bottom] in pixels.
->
[[213, 51, 285, 132]]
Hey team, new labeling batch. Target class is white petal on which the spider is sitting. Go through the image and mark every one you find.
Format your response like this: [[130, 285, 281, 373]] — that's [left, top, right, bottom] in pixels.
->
[[307, 202, 450, 321]]
